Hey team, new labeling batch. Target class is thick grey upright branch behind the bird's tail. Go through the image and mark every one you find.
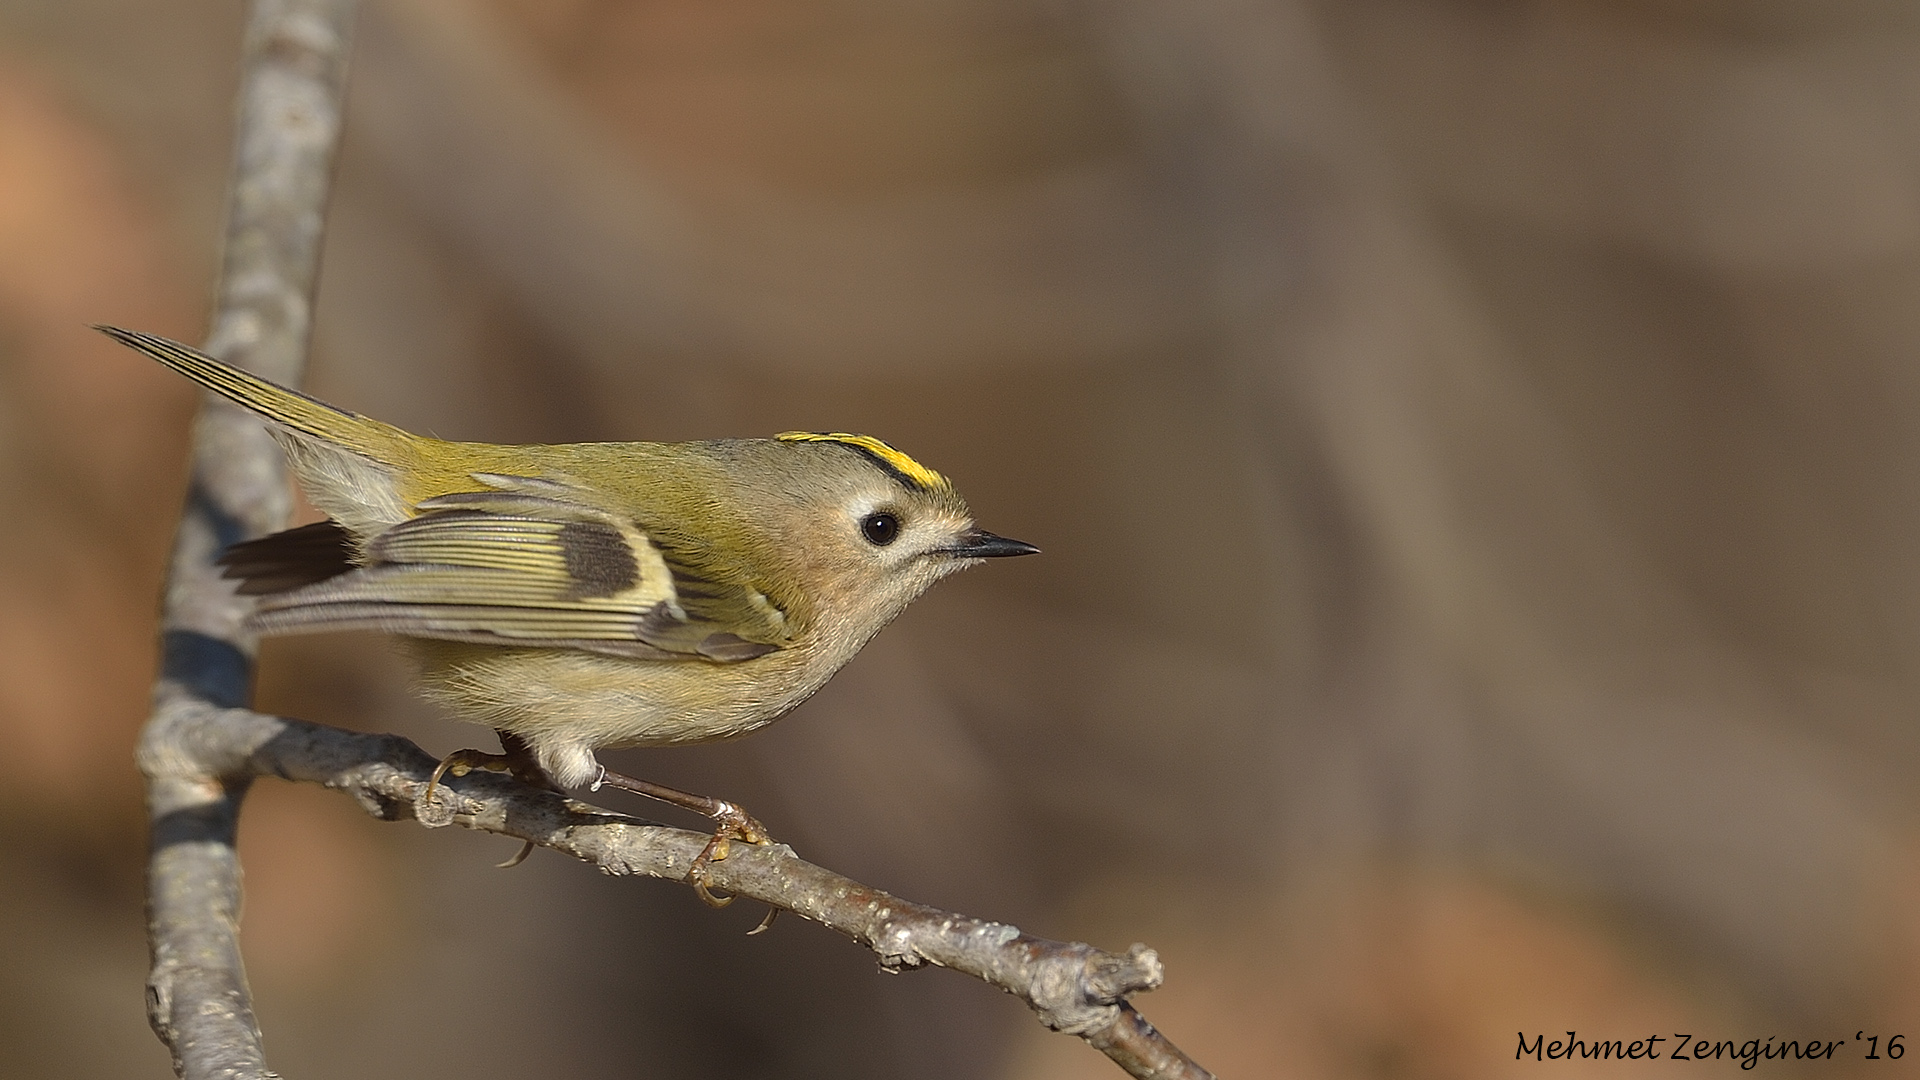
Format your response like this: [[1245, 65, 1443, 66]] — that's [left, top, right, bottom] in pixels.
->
[[138, 0, 353, 1078]]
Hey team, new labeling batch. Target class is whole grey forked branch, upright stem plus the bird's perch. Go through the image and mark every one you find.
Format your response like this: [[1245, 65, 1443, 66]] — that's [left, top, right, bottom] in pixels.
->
[[138, 0, 1210, 1080]]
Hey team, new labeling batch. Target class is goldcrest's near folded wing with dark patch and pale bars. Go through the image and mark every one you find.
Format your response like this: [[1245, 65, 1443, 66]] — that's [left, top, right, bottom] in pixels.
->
[[250, 475, 785, 661]]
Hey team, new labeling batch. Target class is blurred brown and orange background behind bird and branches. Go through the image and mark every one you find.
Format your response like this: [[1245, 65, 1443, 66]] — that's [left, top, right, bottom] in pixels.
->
[[0, 0, 1920, 1080]]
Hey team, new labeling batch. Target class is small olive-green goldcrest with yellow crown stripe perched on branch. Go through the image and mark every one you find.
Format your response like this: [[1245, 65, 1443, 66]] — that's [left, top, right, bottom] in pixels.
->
[[100, 327, 1037, 896]]
